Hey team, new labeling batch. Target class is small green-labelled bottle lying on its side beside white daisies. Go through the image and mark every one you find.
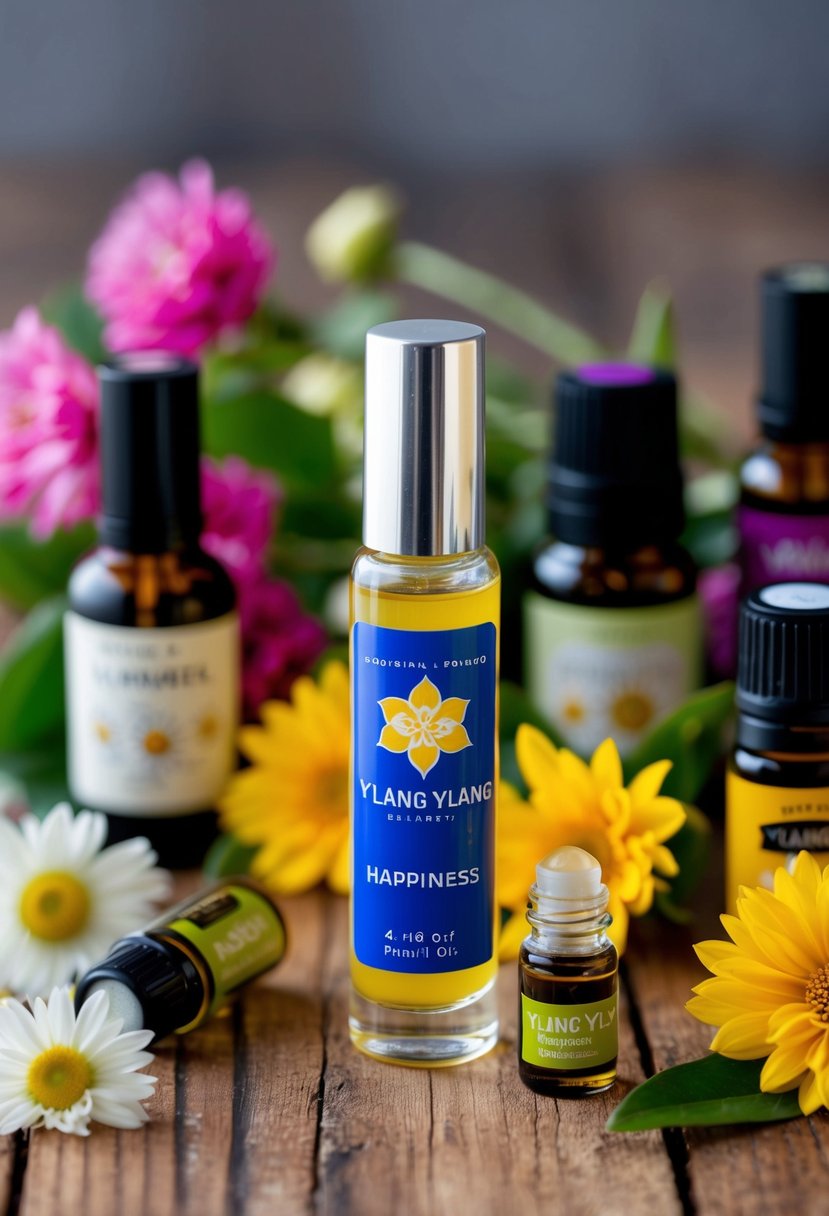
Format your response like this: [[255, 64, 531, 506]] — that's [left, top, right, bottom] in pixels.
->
[[75, 877, 287, 1041]]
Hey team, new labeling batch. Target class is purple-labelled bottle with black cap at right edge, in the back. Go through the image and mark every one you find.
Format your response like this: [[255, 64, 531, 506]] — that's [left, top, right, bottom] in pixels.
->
[[739, 263, 829, 592]]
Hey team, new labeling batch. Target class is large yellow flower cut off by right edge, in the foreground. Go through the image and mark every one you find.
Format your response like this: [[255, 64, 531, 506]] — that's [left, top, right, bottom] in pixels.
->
[[687, 852, 829, 1115]]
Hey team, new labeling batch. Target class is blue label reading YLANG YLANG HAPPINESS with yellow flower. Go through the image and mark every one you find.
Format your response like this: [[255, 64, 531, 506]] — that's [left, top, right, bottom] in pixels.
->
[[353, 623, 496, 974]]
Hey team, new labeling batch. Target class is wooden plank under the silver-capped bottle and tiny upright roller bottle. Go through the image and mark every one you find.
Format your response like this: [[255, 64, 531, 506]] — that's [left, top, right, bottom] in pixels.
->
[[317, 903, 681, 1216]]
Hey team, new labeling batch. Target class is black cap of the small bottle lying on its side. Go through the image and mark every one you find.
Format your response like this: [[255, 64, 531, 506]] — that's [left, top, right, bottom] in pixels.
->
[[75, 936, 210, 1041]]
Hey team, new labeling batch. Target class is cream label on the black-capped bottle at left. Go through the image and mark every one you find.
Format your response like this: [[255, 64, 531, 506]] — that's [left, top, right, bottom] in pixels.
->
[[64, 612, 239, 817]]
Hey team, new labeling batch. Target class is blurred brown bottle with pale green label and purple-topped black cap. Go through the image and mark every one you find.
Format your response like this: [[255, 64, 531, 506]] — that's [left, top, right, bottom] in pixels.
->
[[524, 364, 701, 755]]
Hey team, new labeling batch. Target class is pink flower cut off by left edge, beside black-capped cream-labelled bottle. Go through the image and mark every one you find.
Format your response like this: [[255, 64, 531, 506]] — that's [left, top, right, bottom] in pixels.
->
[[0, 308, 98, 536]]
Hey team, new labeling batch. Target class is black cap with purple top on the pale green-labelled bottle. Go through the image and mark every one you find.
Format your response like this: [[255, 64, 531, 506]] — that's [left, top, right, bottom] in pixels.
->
[[548, 364, 684, 551]]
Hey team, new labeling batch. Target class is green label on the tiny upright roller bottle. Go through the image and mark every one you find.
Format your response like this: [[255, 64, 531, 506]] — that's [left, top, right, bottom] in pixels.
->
[[521, 992, 619, 1069]]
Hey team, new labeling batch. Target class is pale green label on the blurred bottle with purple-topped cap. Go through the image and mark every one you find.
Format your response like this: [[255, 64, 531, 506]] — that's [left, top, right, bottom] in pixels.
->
[[524, 592, 703, 755]]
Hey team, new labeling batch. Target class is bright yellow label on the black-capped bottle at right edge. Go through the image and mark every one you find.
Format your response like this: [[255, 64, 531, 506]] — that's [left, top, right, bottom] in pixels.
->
[[726, 771, 829, 912]]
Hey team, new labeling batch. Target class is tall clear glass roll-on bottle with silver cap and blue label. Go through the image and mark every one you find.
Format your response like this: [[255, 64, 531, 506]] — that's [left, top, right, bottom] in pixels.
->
[[350, 321, 501, 1065]]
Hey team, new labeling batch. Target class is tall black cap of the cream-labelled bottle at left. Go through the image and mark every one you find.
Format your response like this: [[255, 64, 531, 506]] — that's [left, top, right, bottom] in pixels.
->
[[98, 350, 202, 553]]
